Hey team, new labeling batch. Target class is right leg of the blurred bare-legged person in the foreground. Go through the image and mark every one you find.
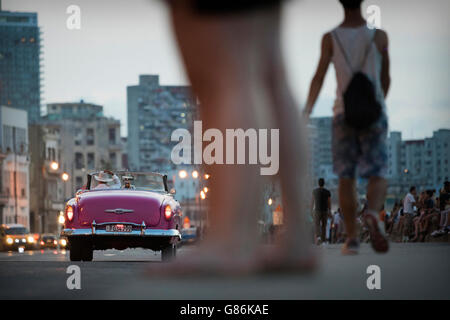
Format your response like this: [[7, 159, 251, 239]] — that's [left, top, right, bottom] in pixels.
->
[[255, 8, 315, 268]]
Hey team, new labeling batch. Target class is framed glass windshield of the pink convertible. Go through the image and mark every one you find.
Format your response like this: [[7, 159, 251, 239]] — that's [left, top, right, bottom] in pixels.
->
[[90, 171, 166, 192]]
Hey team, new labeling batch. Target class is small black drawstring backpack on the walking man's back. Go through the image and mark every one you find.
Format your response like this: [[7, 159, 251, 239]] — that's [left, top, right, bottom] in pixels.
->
[[333, 31, 382, 130]]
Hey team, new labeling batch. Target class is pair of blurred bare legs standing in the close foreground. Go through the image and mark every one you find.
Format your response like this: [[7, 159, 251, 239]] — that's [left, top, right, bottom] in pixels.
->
[[158, 0, 315, 271]]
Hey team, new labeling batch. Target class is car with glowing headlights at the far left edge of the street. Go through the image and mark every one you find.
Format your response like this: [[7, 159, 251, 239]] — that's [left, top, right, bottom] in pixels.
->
[[0, 224, 36, 251]]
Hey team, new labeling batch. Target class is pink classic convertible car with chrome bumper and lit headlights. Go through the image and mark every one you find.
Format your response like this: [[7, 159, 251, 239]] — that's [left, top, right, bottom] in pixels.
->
[[61, 171, 181, 261]]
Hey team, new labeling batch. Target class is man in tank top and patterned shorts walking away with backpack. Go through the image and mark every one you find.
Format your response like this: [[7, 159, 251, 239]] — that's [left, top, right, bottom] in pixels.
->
[[305, 0, 390, 254]]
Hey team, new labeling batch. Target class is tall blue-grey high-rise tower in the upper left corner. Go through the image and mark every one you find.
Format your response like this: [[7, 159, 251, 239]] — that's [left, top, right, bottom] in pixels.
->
[[0, 11, 41, 123]]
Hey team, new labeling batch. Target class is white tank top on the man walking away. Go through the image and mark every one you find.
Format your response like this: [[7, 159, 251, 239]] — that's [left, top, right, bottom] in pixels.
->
[[331, 25, 386, 116]]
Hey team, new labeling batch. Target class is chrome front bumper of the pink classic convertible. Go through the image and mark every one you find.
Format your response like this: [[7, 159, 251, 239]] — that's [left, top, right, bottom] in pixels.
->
[[61, 229, 181, 240]]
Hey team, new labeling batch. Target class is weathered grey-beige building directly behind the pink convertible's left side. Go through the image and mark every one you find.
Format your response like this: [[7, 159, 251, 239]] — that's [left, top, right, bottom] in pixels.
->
[[42, 101, 123, 199]]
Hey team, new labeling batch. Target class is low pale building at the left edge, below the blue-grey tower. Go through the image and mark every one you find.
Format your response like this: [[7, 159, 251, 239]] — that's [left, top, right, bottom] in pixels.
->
[[0, 106, 30, 228]]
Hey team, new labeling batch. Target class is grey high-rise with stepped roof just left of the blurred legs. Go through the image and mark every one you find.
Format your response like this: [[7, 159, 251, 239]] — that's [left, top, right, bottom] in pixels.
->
[[127, 75, 197, 173]]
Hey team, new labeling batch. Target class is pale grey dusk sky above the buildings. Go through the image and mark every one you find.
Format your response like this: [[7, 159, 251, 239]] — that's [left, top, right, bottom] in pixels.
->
[[2, 0, 450, 139]]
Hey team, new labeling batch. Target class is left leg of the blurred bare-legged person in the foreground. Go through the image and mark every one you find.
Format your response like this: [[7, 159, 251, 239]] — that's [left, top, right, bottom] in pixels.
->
[[165, 1, 271, 270]]
